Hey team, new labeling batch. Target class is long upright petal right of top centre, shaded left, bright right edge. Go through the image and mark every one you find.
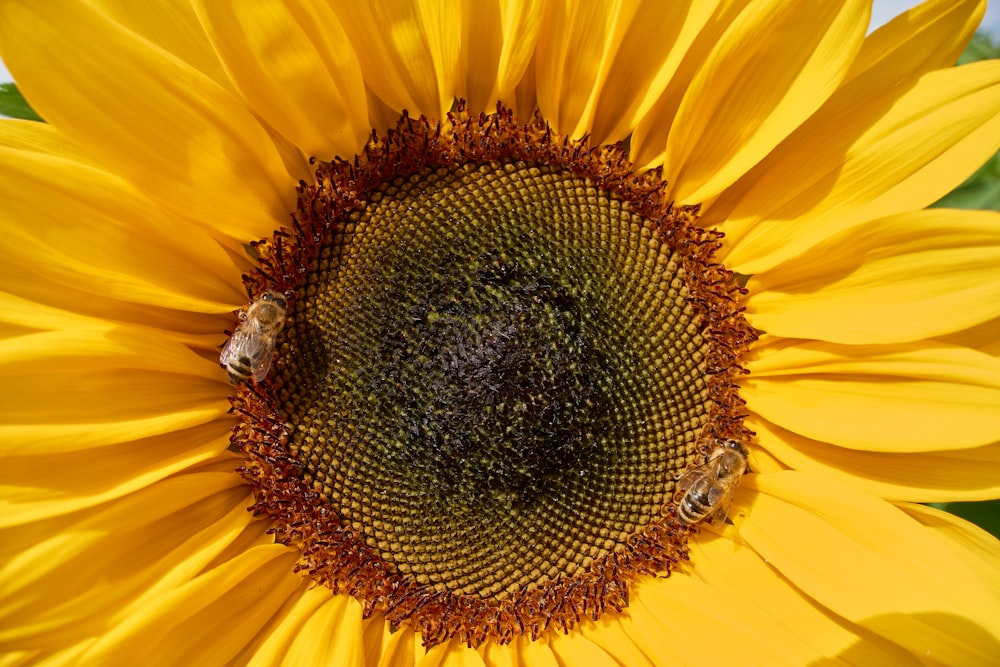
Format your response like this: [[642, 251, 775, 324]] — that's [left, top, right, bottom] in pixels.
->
[[664, 0, 870, 204]]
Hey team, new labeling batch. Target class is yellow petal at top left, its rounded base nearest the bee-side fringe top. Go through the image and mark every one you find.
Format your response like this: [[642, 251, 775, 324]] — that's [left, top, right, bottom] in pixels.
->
[[197, 0, 370, 160]]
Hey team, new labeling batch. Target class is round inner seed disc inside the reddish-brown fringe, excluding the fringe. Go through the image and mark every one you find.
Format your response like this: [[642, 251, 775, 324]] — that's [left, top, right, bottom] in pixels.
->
[[276, 163, 707, 599]]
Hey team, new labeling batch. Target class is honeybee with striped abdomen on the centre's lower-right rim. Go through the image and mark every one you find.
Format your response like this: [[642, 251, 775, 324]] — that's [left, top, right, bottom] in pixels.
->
[[677, 440, 747, 526]]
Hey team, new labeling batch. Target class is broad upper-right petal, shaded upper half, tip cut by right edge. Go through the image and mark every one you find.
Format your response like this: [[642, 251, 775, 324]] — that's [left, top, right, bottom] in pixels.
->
[[706, 61, 1000, 274]]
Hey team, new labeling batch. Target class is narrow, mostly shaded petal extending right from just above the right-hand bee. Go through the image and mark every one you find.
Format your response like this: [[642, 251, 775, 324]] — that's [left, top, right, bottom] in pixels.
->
[[746, 415, 1000, 502]]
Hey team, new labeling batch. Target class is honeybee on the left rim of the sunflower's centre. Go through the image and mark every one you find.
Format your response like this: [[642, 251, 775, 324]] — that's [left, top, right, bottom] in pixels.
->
[[219, 290, 288, 384]]
